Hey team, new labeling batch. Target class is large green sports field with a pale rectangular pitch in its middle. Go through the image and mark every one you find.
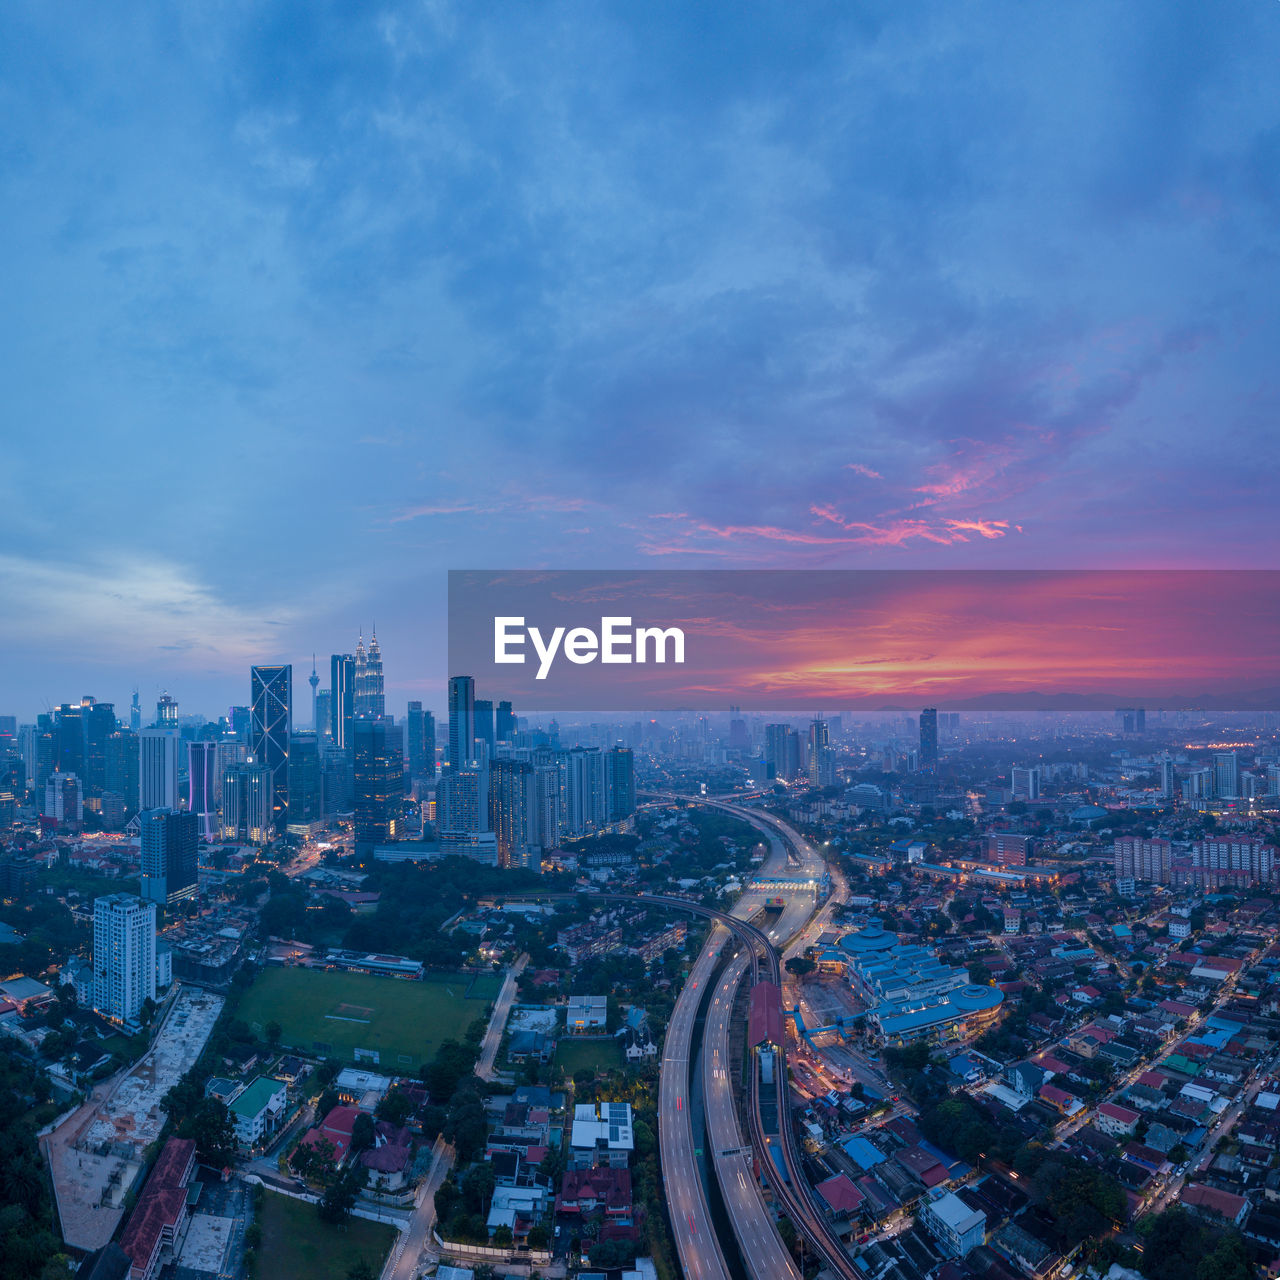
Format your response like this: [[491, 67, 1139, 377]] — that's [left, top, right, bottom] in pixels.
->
[[239, 968, 493, 1071]]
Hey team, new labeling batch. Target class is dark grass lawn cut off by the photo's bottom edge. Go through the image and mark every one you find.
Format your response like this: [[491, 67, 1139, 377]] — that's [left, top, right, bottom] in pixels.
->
[[257, 1192, 396, 1280]]
